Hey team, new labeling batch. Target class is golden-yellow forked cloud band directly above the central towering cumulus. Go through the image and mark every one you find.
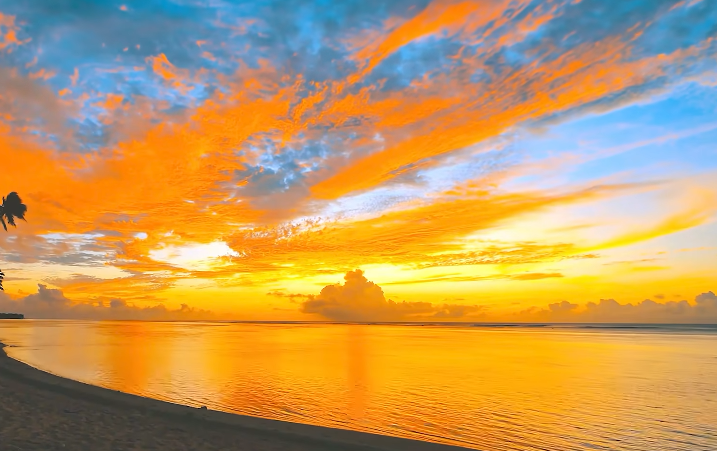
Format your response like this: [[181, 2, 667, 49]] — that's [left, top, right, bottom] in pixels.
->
[[215, 186, 629, 278]]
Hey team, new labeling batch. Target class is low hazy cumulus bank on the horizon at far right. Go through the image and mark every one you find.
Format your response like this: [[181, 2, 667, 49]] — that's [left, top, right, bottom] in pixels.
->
[[507, 291, 717, 324]]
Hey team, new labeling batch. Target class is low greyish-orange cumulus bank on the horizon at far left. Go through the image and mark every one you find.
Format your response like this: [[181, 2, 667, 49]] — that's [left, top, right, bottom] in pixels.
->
[[0, 284, 214, 320]]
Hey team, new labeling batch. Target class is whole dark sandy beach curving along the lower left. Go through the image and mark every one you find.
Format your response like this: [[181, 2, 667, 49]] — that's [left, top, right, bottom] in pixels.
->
[[0, 343, 465, 451]]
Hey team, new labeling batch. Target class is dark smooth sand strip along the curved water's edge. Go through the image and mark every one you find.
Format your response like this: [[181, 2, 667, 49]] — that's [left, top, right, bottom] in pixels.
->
[[0, 343, 469, 451]]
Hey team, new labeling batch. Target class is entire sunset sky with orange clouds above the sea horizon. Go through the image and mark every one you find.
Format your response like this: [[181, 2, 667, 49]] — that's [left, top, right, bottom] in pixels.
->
[[0, 0, 717, 322]]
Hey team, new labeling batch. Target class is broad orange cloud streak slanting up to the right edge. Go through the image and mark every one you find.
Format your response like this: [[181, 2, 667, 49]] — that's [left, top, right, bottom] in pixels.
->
[[311, 31, 711, 199]]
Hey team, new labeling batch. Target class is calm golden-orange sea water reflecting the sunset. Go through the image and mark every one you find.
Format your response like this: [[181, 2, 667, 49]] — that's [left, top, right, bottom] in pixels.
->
[[0, 320, 717, 451]]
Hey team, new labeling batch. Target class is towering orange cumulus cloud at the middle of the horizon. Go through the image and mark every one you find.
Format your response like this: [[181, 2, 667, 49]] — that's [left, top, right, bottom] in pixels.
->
[[301, 269, 481, 321]]
